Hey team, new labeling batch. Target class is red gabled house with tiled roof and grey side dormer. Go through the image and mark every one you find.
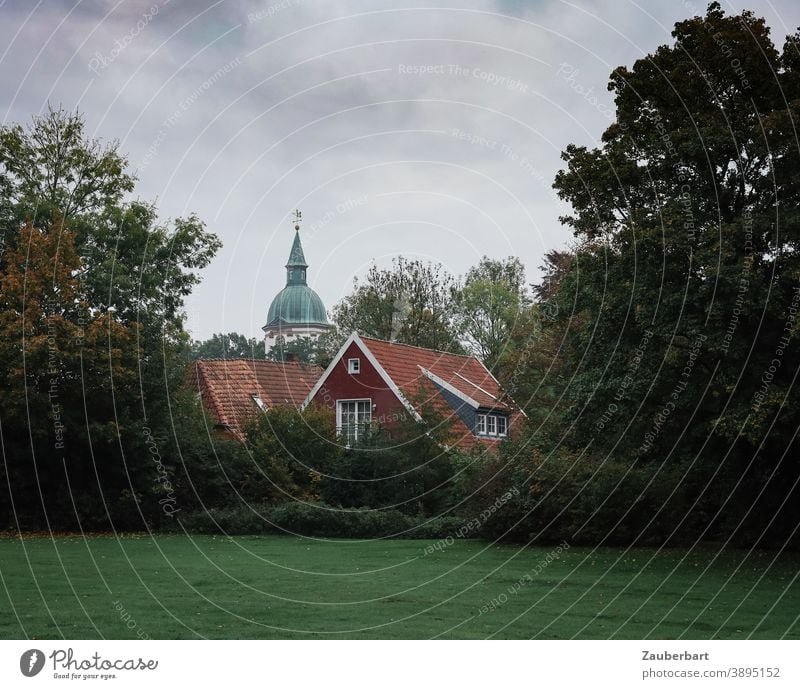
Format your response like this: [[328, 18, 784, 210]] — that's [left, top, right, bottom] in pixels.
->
[[303, 333, 524, 449]]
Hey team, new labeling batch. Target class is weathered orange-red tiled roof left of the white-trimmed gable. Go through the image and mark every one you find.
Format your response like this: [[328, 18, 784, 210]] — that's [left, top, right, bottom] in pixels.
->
[[190, 359, 322, 440]]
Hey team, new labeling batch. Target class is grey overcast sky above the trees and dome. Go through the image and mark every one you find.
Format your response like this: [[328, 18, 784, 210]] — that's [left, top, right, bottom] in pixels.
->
[[0, 0, 800, 338]]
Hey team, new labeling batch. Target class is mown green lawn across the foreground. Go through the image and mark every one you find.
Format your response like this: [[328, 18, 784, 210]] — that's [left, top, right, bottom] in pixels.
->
[[0, 536, 800, 639]]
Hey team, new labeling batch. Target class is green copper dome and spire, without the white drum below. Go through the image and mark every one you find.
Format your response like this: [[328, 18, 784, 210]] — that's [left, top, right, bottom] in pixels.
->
[[265, 226, 328, 328]]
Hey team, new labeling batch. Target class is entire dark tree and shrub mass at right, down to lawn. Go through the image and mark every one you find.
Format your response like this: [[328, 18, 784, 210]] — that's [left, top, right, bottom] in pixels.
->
[[466, 3, 800, 545]]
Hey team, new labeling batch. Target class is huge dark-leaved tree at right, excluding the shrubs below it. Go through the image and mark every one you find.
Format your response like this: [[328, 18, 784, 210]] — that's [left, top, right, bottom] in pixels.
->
[[543, 3, 800, 544]]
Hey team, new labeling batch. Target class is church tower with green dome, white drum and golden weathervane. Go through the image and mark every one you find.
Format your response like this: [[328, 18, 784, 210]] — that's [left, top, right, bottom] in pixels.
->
[[262, 211, 332, 351]]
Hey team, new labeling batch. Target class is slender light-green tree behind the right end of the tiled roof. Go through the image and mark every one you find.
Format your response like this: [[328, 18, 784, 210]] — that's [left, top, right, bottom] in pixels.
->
[[453, 256, 529, 373]]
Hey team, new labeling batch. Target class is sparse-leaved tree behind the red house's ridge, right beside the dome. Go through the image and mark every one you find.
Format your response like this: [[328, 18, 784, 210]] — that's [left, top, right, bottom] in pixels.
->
[[333, 256, 461, 352]]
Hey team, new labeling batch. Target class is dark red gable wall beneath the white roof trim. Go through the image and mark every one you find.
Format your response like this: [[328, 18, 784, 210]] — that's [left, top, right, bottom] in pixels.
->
[[312, 342, 408, 426]]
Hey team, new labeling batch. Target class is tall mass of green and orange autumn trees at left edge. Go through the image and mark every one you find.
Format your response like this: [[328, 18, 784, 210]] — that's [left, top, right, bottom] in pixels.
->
[[0, 109, 220, 528]]
